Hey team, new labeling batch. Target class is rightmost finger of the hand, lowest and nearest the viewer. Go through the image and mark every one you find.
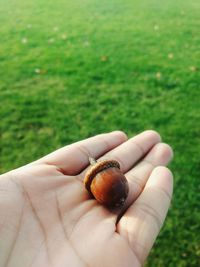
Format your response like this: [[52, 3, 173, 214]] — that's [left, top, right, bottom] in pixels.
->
[[117, 167, 173, 264]]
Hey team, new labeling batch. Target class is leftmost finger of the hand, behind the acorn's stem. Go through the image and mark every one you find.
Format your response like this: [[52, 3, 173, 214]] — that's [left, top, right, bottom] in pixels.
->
[[37, 131, 127, 175]]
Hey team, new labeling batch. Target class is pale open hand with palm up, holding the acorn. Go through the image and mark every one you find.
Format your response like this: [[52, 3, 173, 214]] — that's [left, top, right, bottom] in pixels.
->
[[0, 130, 173, 267]]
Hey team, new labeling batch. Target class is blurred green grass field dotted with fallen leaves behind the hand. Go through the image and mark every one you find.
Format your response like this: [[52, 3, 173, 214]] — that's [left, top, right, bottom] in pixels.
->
[[0, 0, 200, 267]]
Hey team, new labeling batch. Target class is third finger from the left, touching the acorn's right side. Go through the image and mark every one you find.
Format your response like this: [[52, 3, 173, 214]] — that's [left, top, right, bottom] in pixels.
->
[[125, 143, 173, 209]]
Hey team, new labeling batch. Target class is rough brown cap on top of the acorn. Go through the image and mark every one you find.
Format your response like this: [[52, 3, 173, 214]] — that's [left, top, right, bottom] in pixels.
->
[[84, 160, 120, 193]]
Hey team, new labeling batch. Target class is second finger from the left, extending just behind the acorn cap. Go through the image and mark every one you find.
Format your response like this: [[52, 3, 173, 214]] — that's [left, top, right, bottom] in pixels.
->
[[81, 130, 161, 180]]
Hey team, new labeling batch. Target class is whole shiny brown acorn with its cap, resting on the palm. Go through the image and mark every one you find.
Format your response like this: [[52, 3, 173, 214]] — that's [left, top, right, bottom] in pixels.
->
[[84, 158, 129, 207]]
